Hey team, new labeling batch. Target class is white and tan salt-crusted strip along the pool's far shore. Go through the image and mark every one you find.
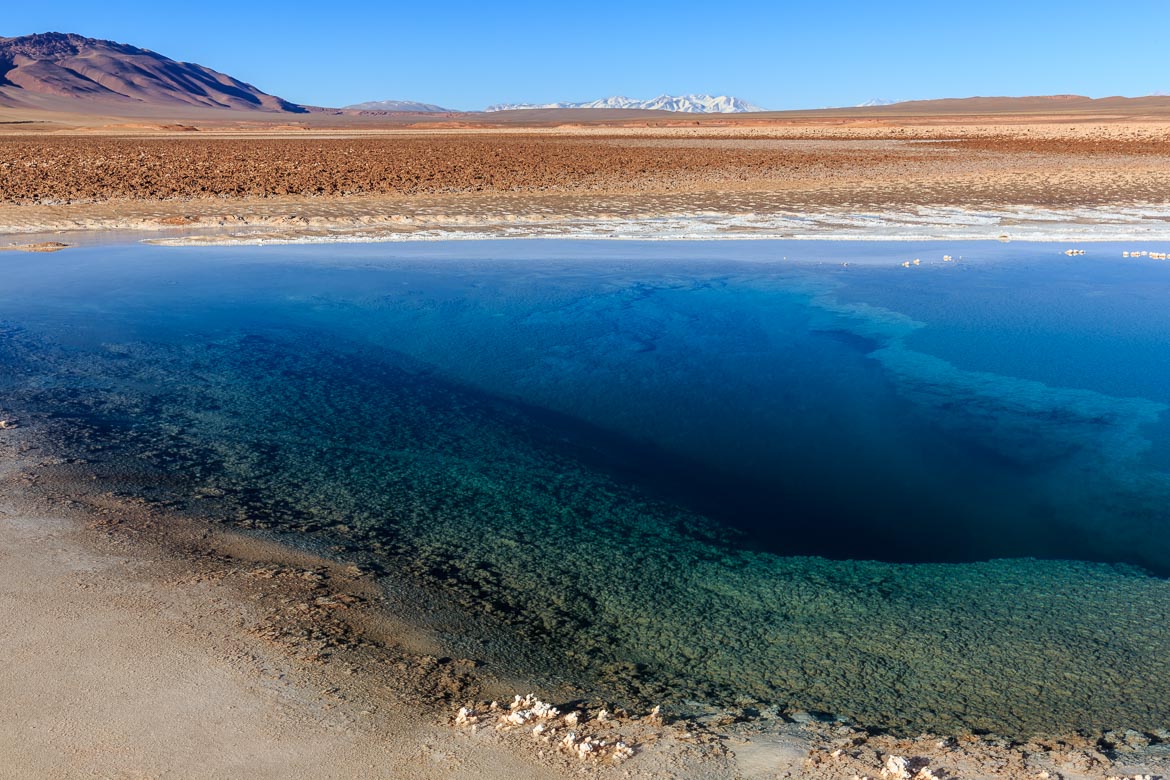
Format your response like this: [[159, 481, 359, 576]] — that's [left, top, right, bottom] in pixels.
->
[[0, 201, 1170, 251]]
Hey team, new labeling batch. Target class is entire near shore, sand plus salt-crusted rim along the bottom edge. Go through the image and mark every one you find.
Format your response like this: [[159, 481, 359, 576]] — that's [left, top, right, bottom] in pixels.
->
[[0, 350, 1170, 780]]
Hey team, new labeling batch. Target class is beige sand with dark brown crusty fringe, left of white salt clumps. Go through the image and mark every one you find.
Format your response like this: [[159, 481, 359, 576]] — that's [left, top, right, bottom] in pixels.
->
[[0, 418, 599, 778]]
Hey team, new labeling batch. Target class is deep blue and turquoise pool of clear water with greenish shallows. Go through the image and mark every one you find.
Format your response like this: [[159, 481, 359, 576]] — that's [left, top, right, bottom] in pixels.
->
[[0, 241, 1170, 736]]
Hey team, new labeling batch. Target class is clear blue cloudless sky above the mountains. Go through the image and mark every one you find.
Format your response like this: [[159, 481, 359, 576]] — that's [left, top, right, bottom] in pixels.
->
[[0, 0, 1170, 109]]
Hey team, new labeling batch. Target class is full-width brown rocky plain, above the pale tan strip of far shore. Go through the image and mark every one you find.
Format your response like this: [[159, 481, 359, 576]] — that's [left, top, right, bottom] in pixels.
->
[[0, 125, 1170, 206]]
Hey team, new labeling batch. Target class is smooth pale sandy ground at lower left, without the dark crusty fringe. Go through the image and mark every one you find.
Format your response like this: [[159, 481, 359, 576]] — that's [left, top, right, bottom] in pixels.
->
[[0, 432, 589, 778]]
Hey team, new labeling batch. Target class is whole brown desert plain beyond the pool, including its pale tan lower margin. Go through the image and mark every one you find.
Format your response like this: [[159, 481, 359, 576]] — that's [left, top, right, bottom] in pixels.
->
[[0, 119, 1170, 238]]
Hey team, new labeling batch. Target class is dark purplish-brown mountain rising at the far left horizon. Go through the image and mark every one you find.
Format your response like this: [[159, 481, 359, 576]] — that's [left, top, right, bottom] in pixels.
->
[[0, 33, 304, 113]]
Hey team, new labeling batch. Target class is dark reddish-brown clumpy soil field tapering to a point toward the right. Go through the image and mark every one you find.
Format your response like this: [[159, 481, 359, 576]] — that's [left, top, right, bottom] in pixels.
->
[[0, 134, 944, 203]]
